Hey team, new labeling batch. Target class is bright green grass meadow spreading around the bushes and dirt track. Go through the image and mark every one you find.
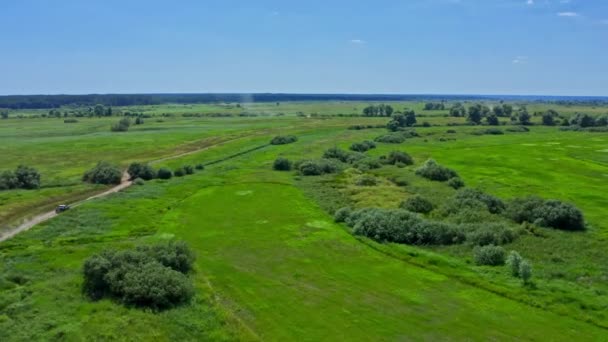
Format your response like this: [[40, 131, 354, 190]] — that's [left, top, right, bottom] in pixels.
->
[[0, 103, 608, 341]]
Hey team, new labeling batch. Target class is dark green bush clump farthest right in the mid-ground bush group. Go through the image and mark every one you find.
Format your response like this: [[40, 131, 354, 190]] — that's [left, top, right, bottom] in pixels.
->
[[506, 196, 585, 230]]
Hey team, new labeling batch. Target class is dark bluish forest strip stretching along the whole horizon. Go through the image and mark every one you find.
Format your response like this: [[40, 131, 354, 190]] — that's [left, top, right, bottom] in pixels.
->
[[0, 93, 608, 109]]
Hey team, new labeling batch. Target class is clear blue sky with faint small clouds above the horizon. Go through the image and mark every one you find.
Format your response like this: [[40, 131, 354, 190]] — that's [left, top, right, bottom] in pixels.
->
[[0, 0, 608, 96]]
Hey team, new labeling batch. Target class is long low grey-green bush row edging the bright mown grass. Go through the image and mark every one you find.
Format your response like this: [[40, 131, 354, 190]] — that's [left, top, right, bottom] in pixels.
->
[[334, 208, 516, 245]]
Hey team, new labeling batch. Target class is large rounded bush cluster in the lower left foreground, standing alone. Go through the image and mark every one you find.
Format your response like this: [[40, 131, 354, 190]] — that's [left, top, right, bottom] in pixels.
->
[[83, 241, 195, 310]]
